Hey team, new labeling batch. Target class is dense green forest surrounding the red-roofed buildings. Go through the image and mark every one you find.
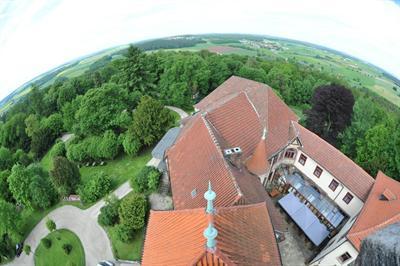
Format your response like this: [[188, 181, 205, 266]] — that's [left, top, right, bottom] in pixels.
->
[[0, 44, 400, 258]]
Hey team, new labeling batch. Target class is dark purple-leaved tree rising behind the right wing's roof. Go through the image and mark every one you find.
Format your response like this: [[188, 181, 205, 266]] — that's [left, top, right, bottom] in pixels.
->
[[306, 85, 354, 145]]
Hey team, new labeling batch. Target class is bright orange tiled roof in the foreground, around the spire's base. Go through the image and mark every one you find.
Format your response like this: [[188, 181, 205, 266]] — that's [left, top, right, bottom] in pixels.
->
[[142, 203, 281, 266]]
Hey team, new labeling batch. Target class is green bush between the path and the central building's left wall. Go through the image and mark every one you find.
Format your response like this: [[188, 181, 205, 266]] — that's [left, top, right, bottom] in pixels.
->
[[131, 166, 161, 193]]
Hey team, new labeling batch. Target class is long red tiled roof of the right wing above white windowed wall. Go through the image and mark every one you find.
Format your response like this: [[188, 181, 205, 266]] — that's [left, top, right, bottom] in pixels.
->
[[293, 122, 374, 202]]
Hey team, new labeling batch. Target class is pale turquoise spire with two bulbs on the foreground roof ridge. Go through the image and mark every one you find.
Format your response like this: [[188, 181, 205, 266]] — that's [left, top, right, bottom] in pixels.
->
[[203, 181, 218, 250]]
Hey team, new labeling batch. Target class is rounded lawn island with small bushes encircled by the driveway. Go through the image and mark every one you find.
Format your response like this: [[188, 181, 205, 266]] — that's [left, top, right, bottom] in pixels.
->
[[34, 229, 85, 266]]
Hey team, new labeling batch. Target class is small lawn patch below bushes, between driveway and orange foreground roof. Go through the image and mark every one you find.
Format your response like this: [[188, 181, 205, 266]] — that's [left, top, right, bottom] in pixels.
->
[[106, 227, 144, 260]]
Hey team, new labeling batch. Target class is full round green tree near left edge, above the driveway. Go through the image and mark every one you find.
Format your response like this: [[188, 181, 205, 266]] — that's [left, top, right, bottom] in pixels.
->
[[8, 164, 57, 209]]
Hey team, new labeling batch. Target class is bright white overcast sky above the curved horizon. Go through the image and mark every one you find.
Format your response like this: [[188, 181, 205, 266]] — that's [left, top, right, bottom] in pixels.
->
[[0, 0, 400, 99]]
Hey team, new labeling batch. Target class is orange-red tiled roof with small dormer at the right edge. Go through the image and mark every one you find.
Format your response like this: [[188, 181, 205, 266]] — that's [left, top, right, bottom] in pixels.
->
[[347, 172, 400, 250]]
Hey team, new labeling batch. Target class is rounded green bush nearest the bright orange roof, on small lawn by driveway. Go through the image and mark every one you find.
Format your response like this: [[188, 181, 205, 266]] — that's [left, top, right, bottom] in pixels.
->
[[118, 194, 147, 230]]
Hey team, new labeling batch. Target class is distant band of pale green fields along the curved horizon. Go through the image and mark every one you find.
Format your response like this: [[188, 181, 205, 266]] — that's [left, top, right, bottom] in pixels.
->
[[0, 34, 400, 113]]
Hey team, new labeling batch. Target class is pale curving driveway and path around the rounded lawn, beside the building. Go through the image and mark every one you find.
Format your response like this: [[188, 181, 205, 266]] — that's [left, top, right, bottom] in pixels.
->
[[8, 106, 188, 266]]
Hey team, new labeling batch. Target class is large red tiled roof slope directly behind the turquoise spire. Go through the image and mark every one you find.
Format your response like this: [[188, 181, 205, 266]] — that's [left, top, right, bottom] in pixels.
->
[[167, 114, 240, 209]]
